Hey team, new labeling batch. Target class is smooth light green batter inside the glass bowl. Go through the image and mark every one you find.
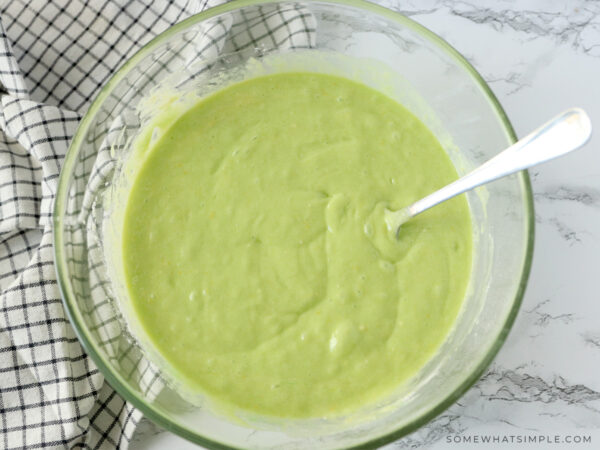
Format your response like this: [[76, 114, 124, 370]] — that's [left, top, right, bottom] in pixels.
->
[[123, 73, 471, 417]]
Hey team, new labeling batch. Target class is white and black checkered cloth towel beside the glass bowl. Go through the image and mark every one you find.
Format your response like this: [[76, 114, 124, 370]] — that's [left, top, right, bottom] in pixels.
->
[[0, 0, 314, 449]]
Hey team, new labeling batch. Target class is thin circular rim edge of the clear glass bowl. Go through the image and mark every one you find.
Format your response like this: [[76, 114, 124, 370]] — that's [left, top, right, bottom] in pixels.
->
[[53, 0, 535, 449]]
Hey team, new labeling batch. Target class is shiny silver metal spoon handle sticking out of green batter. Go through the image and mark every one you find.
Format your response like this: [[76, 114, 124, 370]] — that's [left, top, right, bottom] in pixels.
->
[[385, 108, 592, 236]]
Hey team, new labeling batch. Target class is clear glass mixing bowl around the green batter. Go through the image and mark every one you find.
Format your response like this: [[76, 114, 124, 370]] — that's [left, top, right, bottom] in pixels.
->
[[54, 0, 533, 448]]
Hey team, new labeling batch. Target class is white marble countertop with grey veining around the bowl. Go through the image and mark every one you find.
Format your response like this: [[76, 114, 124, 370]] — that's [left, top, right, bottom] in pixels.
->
[[130, 0, 600, 450]]
